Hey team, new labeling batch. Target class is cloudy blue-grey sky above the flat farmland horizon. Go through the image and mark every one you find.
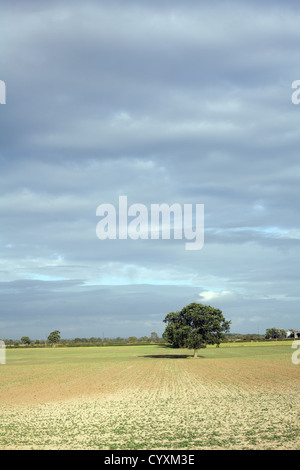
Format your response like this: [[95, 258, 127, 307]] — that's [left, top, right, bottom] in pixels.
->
[[0, 0, 300, 339]]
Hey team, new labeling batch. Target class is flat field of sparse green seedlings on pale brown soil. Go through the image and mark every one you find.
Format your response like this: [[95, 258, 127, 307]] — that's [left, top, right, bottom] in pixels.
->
[[0, 342, 300, 450]]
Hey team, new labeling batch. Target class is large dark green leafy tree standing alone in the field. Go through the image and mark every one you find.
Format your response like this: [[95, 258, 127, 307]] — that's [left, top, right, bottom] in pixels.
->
[[163, 303, 231, 357]]
